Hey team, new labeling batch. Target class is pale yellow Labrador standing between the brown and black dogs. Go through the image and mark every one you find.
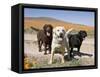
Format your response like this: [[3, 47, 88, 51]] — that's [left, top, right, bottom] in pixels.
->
[[48, 26, 72, 64]]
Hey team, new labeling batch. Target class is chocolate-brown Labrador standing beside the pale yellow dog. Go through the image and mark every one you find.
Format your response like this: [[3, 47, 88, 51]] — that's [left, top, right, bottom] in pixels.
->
[[37, 24, 53, 55]]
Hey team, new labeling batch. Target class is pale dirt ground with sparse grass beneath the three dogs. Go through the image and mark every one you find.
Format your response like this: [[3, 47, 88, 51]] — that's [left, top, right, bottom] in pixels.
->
[[24, 33, 95, 68]]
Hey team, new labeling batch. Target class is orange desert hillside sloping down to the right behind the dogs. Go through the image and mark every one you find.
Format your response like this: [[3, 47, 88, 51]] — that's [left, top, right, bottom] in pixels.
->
[[24, 17, 94, 31]]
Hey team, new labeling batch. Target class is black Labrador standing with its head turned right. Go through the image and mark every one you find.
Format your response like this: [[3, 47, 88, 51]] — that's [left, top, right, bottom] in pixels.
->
[[68, 30, 87, 58]]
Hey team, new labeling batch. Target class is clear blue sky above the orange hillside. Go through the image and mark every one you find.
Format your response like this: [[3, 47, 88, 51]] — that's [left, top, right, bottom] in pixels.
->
[[24, 8, 95, 26]]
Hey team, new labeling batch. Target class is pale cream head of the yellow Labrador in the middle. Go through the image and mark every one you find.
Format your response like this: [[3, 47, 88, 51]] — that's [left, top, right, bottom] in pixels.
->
[[53, 26, 65, 39]]
